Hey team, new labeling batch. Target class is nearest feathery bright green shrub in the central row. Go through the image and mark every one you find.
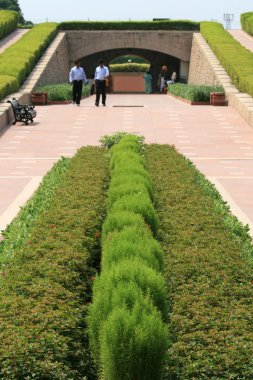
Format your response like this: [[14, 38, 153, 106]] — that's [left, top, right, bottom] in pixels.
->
[[101, 304, 167, 380]]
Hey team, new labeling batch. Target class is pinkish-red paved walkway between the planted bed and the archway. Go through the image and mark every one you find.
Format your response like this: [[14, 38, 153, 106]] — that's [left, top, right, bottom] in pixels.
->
[[0, 94, 253, 233]]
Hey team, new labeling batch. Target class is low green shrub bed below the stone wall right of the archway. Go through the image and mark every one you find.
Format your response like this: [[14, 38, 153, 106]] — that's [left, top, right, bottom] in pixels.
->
[[167, 83, 224, 102]]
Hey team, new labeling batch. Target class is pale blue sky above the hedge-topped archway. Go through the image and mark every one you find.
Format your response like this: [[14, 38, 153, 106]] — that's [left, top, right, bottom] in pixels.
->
[[19, 0, 253, 29]]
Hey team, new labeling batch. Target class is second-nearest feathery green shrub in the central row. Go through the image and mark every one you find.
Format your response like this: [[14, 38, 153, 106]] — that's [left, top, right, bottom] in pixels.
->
[[90, 257, 168, 355]]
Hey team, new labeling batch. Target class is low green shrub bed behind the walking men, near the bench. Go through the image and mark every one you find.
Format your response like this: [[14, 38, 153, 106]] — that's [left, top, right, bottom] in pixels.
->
[[34, 83, 90, 101]]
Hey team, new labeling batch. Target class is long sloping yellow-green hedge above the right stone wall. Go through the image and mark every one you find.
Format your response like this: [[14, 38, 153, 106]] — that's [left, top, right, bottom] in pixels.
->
[[200, 22, 253, 96]]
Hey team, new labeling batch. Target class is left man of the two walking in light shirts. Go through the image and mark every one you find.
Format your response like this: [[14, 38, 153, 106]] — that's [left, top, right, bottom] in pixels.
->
[[69, 59, 88, 106]]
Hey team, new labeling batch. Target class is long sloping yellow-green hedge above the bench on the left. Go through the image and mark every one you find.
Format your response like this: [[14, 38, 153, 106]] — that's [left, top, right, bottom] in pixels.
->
[[0, 22, 58, 98]]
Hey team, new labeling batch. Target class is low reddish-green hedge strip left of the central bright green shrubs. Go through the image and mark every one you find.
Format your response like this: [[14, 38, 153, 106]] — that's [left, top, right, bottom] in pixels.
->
[[0, 147, 109, 380]]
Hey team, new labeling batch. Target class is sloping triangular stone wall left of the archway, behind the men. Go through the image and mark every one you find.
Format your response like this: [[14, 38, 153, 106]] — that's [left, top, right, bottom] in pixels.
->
[[36, 33, 70, 87]]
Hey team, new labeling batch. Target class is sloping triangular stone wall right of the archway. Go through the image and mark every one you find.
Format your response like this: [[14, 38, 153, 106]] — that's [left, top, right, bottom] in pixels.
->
[[188, 33, 221, 86]]
